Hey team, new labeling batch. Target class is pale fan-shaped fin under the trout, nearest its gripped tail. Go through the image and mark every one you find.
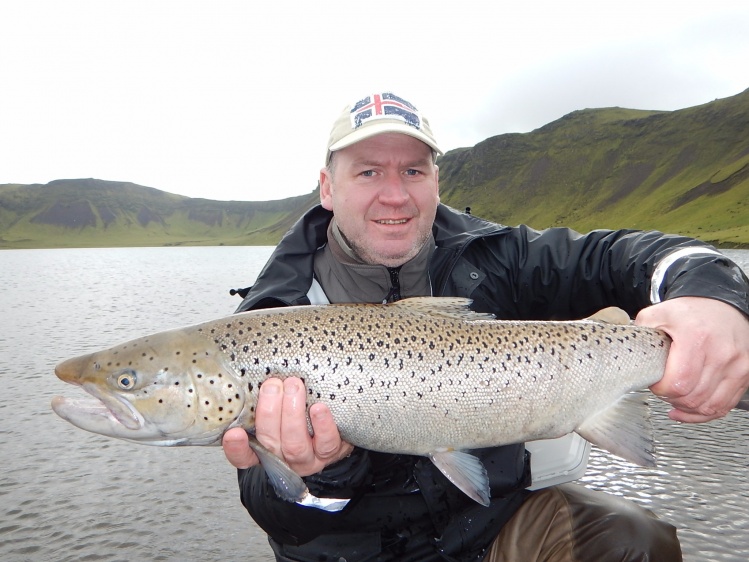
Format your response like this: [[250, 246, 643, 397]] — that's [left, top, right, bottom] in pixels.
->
[[575, 393, 655, 466]]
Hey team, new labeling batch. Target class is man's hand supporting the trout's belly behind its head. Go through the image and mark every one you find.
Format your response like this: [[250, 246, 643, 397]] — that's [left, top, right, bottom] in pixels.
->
[[223, 377, 354, 476]]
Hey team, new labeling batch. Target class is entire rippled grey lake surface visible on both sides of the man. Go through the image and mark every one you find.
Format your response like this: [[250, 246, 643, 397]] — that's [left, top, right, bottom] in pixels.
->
[[0, 247, 749, 562]]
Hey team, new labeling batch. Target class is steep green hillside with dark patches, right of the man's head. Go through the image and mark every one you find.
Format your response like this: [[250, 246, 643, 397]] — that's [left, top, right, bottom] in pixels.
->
[[440, 91, 749, 246]]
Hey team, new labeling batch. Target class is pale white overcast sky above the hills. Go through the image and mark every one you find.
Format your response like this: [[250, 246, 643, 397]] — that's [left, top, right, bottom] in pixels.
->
[[0, 0, 749, 201]]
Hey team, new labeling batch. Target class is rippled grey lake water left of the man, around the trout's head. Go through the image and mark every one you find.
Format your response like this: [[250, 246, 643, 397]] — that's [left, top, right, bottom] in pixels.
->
[[0, 247, 272, 562]]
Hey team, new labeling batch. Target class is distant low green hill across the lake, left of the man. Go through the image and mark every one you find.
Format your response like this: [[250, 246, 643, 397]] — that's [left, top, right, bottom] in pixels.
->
[[0, 179, 318, 248]]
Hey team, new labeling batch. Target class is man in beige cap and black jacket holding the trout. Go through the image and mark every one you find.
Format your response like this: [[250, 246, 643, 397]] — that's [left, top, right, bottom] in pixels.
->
[[223, 89, 749, 562]]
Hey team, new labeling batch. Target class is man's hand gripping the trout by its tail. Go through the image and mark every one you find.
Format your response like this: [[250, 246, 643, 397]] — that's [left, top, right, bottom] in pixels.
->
[[635, 297, 749, 423]]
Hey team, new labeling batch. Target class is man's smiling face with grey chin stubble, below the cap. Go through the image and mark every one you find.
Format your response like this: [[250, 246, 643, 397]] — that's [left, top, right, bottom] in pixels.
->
[[320, 133, 439, 267]]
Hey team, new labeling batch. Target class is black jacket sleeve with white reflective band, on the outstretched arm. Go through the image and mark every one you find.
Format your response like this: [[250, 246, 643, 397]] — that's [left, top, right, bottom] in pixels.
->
[[496, 227, 749, 319]]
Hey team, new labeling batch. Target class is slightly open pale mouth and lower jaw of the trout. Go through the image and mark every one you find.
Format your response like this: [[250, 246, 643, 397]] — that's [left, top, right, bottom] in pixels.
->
[[52, 383, 145, 434]]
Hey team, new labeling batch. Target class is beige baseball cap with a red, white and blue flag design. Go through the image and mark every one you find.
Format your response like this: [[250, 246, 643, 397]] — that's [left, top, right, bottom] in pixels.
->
[[325, 92, 443, 166]]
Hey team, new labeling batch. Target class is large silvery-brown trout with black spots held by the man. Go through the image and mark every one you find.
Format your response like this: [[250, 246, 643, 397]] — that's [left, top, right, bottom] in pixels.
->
[[52, 297, 670, 504]]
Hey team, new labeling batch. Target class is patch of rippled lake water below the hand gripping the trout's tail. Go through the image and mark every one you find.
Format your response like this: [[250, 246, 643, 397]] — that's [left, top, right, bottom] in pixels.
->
[[582, 398, 749, 562]]
